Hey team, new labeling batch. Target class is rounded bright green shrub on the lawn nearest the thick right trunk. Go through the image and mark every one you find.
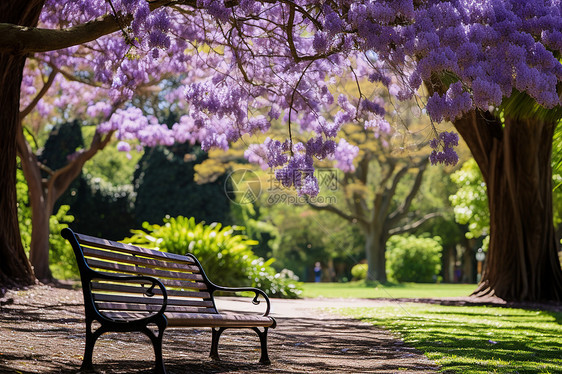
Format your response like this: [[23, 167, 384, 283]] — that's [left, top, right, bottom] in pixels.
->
[[386, 235, 443, 283]]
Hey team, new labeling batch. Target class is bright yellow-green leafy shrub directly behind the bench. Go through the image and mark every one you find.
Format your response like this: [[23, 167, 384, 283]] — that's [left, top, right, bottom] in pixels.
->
[[124, 216, 302, 298]]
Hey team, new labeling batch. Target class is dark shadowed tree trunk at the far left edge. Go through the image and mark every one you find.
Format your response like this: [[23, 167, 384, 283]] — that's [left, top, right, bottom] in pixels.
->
[[0, 0, 43, 284]]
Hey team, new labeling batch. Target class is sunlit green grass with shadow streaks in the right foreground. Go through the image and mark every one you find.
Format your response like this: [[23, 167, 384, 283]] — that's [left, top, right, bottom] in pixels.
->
[[337, 303, 562, 373]]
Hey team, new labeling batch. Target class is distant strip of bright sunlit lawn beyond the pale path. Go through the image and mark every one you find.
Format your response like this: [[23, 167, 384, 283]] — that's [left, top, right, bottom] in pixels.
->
[[303, 281, 476, 298]]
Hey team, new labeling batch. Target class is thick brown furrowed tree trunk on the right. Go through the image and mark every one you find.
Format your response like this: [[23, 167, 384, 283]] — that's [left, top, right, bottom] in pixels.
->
[[455, 112, 562, 301]]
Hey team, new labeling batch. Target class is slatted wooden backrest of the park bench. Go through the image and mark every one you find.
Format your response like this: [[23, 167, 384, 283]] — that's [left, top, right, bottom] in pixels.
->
[[63, 230, 217, 319]]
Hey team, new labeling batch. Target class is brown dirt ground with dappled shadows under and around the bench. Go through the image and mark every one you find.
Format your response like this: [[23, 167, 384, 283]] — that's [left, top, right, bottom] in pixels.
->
[[0, 285, 560, 374]]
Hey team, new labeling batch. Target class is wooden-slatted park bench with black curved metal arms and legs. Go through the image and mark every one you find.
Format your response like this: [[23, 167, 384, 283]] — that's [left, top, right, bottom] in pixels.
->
[[61, 228, 276, 373]]
